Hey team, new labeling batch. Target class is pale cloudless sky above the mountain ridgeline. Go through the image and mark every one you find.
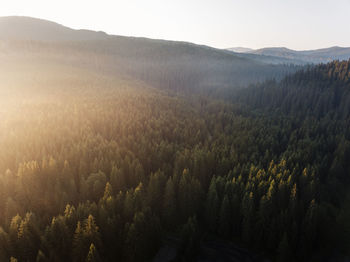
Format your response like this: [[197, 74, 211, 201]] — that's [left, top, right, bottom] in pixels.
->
[[0, 0, 350, 50]]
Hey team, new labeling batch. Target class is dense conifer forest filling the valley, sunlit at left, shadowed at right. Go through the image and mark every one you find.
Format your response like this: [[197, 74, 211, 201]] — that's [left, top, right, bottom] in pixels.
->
[[0, 57, 350, 262]]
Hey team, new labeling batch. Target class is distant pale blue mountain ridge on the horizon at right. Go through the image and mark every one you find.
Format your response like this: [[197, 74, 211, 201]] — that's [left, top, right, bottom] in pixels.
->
[[227, 46, 350, 64]]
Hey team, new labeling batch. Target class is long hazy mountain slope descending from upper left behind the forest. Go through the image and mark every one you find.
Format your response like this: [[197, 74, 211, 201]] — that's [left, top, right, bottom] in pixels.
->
[[0, 17, 295, 91]]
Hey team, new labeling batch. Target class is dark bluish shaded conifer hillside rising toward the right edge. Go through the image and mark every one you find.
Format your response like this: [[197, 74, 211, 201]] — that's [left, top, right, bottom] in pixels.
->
[[232, 60, 350, 120]]
